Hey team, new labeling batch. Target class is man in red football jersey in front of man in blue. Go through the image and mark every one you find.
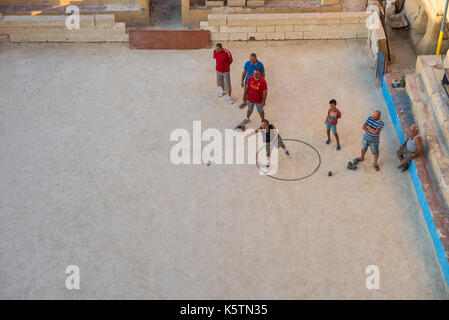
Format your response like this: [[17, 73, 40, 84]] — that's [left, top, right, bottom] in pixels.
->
[[243, 69, 268, 124]]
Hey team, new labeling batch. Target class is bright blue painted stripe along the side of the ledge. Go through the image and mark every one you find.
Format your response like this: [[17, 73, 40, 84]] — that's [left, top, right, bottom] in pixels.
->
[[382, 76, 449, 285]]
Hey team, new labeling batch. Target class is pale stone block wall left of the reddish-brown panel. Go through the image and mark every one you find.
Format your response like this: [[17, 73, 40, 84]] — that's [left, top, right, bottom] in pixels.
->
[[0, 14, 128, 42]]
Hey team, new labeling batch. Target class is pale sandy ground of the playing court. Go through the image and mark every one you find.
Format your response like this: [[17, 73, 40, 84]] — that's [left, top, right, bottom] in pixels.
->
[[0, 41, 448, 299]]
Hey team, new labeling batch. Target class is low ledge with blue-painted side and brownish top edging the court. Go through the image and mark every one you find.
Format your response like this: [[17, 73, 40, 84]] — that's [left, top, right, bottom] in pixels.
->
[[382, 74, 449, 285]]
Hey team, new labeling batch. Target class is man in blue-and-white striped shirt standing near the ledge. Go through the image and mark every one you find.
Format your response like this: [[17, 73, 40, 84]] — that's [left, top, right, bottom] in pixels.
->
[[355, 110, 384, 171]]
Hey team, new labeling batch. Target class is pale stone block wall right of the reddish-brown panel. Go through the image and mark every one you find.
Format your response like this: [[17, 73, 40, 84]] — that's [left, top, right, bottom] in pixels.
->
[[201, 12, 369, 41]]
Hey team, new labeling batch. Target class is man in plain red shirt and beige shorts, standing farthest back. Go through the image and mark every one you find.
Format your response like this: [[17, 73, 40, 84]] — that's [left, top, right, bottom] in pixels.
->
[[214, 43, 234, 104]]
